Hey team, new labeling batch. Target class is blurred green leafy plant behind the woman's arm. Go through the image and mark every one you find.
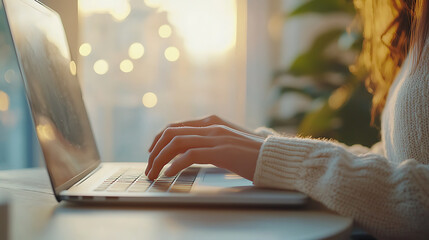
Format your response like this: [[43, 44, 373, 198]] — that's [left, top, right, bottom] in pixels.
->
[[269, 0, 379, 146]]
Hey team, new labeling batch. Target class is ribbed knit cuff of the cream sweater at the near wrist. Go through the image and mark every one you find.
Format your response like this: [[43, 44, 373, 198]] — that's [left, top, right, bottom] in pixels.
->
[[253, 136, 314, 190]]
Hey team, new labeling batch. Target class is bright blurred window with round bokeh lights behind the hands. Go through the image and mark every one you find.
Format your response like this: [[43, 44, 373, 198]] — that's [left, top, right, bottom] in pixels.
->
[[79, 0, 251, 161]]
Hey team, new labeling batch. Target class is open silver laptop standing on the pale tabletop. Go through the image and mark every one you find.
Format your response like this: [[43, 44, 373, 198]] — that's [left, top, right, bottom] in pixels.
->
[[0, 0, 308, 206]]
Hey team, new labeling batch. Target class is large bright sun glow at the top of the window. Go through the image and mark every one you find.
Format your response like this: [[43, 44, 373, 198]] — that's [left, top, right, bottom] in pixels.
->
[[161, 0, 237, 62]]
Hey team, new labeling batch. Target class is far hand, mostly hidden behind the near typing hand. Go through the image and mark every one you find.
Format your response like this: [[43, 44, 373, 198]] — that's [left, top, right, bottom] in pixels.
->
[[149, 115, 263, 152]]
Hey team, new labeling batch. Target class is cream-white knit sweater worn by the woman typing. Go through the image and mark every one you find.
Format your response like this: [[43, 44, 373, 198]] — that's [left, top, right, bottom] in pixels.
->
[[253, 36, 429, 239]]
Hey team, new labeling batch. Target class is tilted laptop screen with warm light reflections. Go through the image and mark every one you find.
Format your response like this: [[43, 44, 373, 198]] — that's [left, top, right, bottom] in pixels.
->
[[3, 0, 100, 190]]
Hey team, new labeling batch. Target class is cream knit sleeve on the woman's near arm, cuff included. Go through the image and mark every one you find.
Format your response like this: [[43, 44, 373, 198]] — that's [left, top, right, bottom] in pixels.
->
[[254, 136, 429, 239]]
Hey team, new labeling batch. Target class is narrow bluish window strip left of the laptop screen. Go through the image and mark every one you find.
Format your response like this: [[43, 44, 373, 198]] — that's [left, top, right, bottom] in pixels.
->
[[0, 3, 40, 170]]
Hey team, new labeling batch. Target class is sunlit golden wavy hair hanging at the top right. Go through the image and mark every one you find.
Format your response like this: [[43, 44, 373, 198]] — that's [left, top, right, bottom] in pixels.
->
[[354, 0, 429, 124]]
